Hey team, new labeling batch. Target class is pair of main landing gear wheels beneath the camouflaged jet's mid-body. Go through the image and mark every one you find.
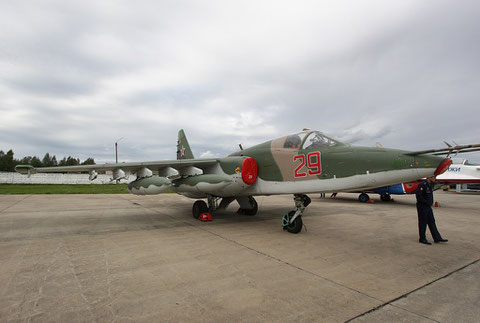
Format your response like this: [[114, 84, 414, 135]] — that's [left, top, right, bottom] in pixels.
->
[[192, 195, 258, 219]]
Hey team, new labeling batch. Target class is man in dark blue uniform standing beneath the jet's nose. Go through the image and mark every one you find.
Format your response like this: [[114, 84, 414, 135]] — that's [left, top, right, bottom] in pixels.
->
[[415, 176, 448, 245]]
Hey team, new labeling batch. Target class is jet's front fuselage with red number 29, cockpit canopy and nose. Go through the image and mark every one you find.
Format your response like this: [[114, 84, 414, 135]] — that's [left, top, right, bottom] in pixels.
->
[[225, 131, 444, 195]]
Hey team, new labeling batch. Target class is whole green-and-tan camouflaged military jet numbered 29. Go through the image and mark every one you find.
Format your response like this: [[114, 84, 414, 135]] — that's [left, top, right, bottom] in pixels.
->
[[16, 129, 480, 233]]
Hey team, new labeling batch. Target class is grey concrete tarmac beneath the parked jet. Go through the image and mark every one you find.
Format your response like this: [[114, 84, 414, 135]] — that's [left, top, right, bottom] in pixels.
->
[[0, 192, 480, 322]]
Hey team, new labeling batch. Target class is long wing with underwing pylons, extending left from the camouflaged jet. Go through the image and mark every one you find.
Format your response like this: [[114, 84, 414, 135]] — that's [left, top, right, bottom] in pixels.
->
[[15, 158, 219, 179]]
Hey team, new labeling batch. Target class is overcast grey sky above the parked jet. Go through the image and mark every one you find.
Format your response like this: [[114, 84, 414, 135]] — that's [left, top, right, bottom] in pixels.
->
[[0, 0, 480, 162]]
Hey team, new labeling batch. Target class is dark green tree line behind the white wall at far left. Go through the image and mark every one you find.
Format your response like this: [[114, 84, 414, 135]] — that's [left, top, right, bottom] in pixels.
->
[[0, 149, 95, 172]]
